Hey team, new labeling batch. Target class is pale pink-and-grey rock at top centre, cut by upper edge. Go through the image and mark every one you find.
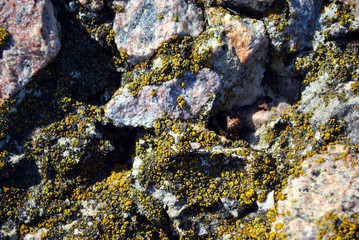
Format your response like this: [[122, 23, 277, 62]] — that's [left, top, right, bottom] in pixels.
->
[[113, 0, 204, 61]]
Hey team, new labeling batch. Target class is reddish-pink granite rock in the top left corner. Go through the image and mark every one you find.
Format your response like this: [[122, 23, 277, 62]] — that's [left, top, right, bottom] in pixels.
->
[[0, 0, 60, 103]]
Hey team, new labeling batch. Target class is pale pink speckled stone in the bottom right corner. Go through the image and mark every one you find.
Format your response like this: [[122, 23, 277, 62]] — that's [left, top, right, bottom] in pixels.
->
[[272, 153, 359, 239]]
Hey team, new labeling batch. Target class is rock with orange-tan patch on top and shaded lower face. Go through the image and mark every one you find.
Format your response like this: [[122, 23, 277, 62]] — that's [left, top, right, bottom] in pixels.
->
[[205, 8, 268, 109]]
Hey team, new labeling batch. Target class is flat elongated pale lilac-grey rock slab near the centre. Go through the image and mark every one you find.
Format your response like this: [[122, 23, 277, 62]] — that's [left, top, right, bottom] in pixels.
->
[[106, 68, 221, 127]]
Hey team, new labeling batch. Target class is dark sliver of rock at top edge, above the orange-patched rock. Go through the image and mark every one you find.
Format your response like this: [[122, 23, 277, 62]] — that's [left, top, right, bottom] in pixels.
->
[[221, 0, 274, 12]]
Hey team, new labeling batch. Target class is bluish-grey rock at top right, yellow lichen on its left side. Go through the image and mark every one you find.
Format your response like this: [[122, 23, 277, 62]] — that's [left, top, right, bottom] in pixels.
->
[[265, 0, 322, 53]]
